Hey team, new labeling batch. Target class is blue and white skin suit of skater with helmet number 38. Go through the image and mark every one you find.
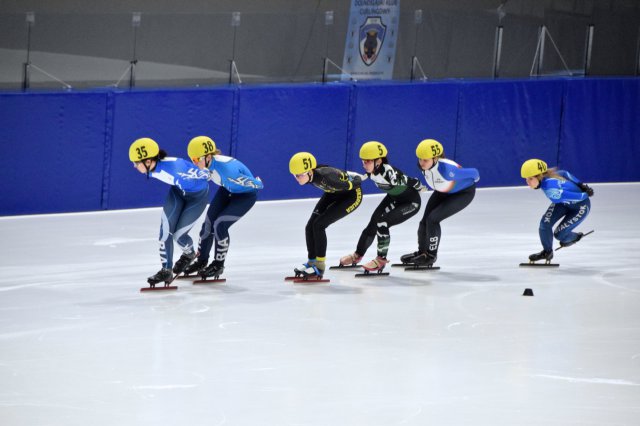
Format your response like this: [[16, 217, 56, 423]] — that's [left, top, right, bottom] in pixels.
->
[[198, 155, 264, 266]]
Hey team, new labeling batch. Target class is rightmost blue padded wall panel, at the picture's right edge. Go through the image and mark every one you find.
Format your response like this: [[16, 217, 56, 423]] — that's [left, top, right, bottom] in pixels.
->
[[559, 78, 640, 182]]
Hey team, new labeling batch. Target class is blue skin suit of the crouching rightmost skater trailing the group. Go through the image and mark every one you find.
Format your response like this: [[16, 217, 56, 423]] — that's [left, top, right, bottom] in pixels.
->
[[539, 170, 591, 251]]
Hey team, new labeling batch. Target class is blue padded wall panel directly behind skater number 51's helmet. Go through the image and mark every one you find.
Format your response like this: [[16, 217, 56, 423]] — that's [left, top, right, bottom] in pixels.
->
[[234, 85, 350, 200]]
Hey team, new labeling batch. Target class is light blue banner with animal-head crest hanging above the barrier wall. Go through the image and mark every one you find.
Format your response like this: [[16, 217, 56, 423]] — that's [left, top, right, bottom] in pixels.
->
[[342, 0, 400, 80]]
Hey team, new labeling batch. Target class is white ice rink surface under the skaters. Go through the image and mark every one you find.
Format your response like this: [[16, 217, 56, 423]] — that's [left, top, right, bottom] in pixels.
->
[[0, 181, 640, 426]]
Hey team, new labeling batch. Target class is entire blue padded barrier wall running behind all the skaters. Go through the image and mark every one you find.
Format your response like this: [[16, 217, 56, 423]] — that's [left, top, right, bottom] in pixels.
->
[[0, 78, 640, 215]]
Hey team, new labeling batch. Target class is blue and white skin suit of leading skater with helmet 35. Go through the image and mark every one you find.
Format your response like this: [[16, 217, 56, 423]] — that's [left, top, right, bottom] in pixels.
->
[[149, 157, 209, 269]]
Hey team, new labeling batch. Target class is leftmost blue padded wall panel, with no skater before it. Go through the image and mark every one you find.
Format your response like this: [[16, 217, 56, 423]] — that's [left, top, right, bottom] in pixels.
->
[[0, 93, 106, 215]]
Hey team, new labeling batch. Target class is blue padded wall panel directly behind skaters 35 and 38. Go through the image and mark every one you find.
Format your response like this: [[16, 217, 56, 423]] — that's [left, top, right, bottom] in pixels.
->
[[107, 89, 235, 209]]
